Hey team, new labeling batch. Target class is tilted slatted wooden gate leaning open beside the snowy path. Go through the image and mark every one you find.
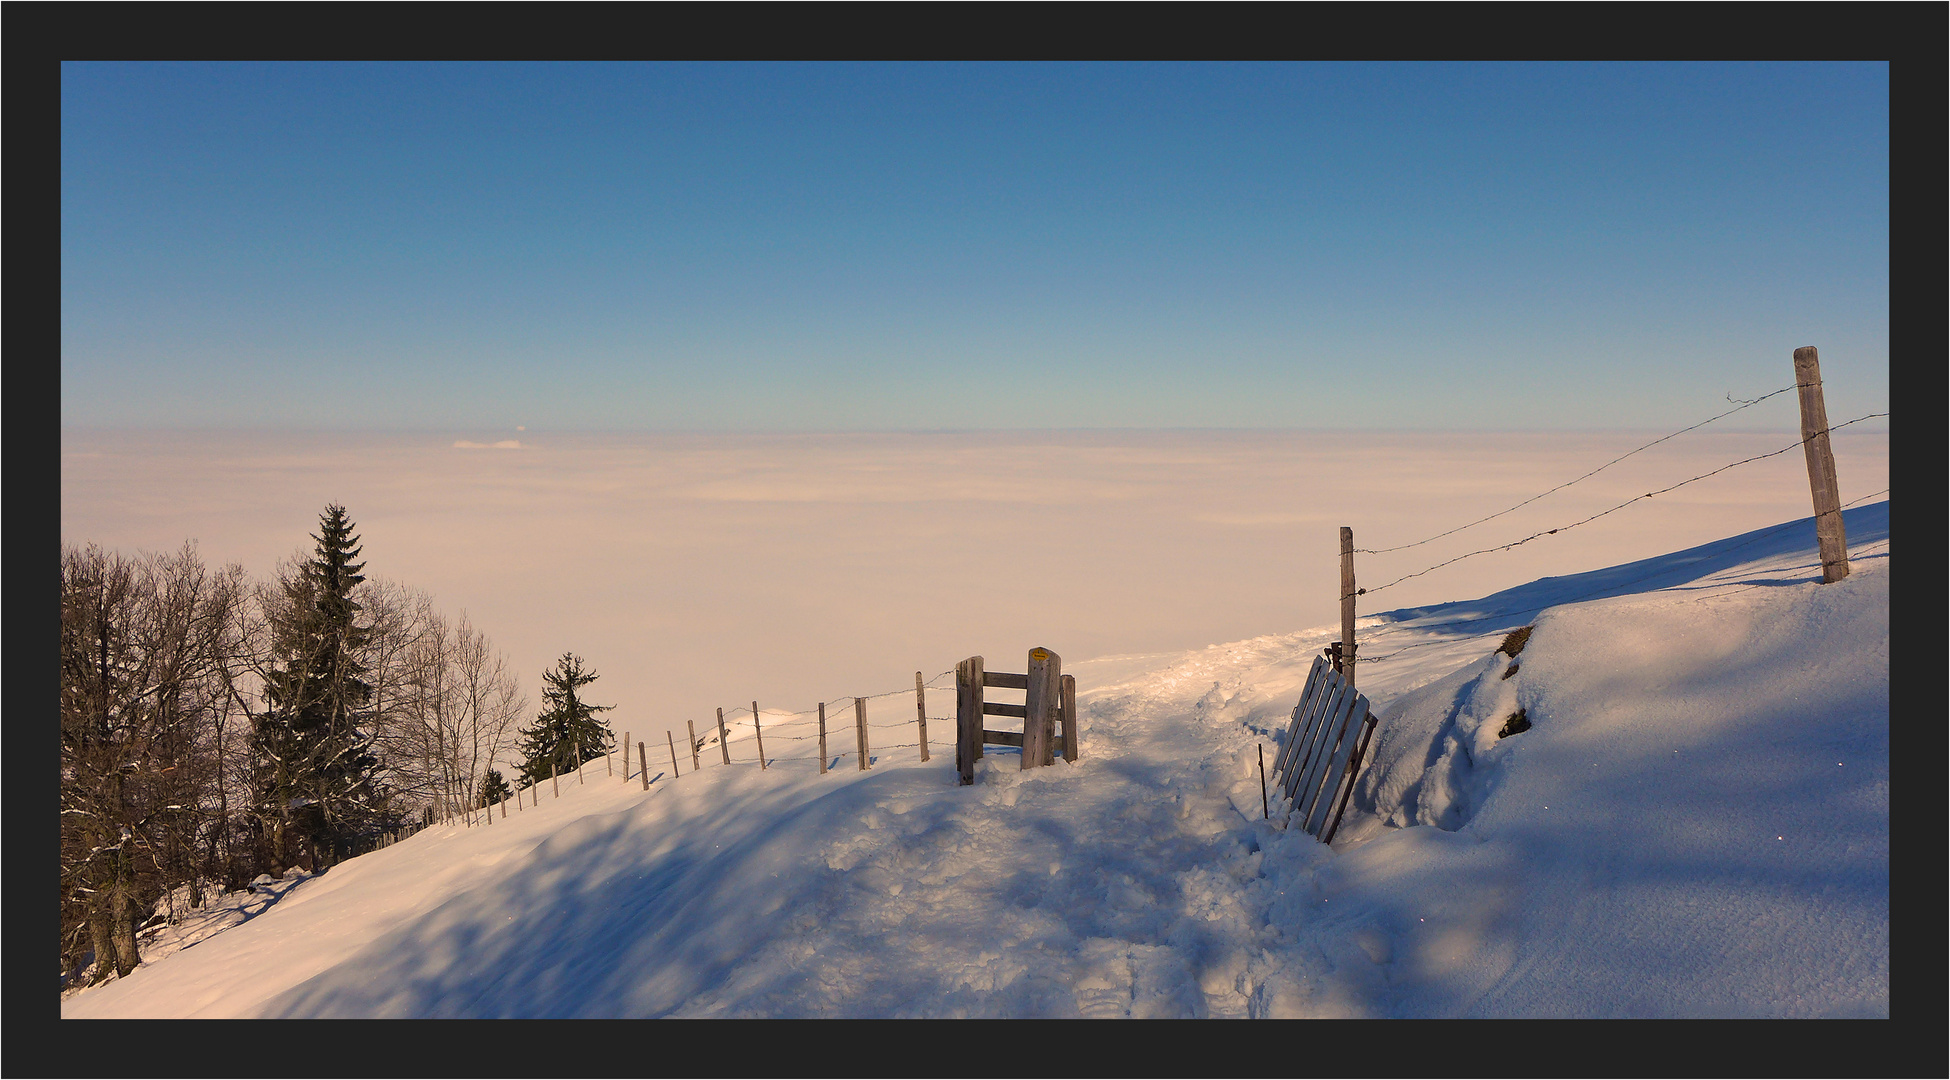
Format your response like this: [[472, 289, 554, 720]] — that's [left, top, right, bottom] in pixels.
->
[[1273, 657, 1375, 844]]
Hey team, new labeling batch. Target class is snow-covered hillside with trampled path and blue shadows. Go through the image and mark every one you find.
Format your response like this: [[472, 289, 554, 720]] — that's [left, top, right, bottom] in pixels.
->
[[62, 503, 1890, 1018]]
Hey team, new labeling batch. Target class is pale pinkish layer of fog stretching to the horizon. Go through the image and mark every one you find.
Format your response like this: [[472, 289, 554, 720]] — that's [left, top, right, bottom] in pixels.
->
[[60, 427, 1888, 768]]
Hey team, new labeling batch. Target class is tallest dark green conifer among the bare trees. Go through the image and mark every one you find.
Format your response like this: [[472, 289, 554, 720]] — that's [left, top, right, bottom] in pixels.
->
[[252, 505, 396, 869]]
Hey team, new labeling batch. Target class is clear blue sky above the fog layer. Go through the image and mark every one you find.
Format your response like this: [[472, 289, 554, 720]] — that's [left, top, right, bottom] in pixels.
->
[[60, 62, 1890, 435]]
